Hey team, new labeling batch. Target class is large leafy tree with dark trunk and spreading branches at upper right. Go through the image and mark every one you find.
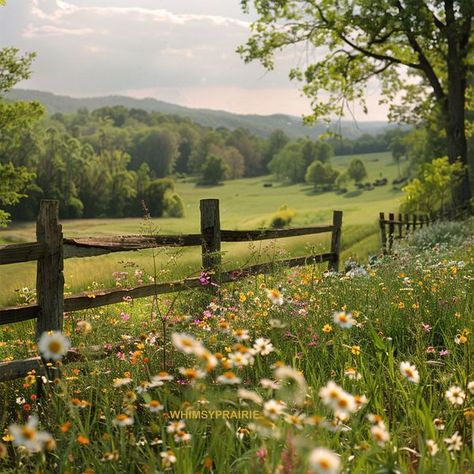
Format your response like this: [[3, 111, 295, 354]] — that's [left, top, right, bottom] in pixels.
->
[[239, 0, 474, 204]]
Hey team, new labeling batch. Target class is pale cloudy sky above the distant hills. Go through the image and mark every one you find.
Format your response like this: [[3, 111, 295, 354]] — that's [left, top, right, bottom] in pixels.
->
[[0, 0, 386, 120]]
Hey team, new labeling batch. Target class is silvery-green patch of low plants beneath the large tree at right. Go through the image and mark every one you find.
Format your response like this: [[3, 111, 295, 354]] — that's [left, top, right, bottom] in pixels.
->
[[400, 222, 471, 254]]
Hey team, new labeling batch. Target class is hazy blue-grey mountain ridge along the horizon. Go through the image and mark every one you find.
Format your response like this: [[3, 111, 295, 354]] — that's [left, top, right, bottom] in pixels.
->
[[5, 89, 390, 138]]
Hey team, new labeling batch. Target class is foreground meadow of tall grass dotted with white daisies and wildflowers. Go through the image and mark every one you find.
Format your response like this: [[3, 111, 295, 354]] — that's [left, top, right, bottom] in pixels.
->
[[0, 225, 474, 474]]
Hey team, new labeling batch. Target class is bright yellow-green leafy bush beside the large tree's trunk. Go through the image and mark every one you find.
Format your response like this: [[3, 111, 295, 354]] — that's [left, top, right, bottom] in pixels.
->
[[402, 156, 465, 214]]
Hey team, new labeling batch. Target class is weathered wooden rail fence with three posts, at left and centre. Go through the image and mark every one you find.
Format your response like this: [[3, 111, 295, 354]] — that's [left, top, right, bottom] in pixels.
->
[[0, 199, 342, 382]]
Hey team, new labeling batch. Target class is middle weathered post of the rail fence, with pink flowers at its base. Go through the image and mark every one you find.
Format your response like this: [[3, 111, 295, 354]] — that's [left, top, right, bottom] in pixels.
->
[[199, 199, 221, 282]]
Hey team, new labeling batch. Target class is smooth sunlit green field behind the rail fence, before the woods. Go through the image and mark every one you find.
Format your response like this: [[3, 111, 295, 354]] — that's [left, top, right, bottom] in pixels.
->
[[0, 153, 401, 305]]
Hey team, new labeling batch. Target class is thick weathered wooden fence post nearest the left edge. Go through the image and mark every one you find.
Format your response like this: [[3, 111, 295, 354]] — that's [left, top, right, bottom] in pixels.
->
[[36, 200, 64, 338]]
